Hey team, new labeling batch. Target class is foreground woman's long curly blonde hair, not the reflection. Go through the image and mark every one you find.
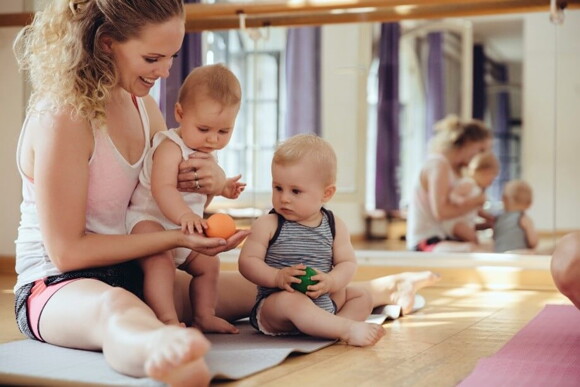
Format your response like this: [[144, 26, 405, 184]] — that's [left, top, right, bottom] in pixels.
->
[[13, 0, 184, 122]]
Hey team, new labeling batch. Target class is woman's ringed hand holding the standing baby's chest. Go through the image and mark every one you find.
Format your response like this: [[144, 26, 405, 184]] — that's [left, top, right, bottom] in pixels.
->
[[177, 152, 226, 195]]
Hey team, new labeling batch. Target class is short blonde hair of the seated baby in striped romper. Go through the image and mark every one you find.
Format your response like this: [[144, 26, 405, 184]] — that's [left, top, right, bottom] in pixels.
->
[[272, 134, 336, 185]]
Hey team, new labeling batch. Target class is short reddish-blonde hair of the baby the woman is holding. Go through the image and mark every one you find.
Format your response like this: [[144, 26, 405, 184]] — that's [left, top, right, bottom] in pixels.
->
[[177, 63, 242, 107]]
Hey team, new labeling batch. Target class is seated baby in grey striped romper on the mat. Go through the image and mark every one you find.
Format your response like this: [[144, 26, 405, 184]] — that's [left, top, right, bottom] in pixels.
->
[[239, 135, 385, 346]]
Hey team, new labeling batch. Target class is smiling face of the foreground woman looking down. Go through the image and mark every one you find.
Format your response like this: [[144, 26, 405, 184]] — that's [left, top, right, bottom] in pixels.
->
[[105, 17, 185, 97]]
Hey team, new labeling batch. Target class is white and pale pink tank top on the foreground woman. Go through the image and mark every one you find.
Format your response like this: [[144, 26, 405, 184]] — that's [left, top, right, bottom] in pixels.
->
[[14, 98, 150, 290]]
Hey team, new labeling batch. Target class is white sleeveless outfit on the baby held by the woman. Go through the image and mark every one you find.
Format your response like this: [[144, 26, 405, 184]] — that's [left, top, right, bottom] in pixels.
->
[[126, 129, 207, 266]]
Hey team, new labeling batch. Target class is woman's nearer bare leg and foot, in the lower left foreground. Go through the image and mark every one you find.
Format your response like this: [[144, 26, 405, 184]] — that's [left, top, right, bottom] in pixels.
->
[[40, 279, 209, 385]]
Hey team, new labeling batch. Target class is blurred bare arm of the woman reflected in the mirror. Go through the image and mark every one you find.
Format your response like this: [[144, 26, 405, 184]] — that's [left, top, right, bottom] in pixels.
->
[[421, 162, 485, 221]]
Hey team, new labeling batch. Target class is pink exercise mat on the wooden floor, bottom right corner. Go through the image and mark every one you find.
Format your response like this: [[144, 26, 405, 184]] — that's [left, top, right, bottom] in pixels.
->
[[459, 305, 580, 387]]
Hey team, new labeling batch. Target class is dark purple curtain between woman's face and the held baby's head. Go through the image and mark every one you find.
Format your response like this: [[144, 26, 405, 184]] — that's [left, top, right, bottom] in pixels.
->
[[159, 0, 203, 128]]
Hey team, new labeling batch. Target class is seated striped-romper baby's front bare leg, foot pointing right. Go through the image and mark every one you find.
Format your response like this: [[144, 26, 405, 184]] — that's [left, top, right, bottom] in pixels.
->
[[259, 291, 385, 347]]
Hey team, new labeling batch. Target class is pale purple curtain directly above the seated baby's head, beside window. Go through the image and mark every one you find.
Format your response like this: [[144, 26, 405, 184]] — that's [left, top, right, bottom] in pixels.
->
[[285, 27, 321, 137]]
